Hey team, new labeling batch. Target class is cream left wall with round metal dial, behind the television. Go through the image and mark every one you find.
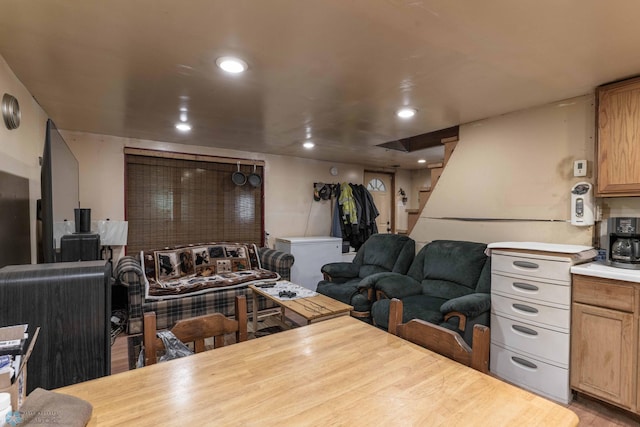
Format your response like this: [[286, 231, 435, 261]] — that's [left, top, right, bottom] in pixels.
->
[[0, 56, 48, 263]]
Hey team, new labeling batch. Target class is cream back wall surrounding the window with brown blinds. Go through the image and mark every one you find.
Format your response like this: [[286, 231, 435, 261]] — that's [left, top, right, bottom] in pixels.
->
[[61, 131, 364, 251]]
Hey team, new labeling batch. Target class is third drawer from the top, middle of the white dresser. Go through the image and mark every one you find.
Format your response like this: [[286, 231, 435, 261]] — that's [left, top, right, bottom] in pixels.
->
[[491, 293, 571, 332]]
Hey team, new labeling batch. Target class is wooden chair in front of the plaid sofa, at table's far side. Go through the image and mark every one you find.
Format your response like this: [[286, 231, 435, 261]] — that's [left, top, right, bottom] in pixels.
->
[[143, 295, 247, 366]]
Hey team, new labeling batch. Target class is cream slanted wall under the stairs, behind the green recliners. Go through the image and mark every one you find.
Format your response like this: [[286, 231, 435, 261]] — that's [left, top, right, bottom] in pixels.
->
[[411, 95, 595, 245]]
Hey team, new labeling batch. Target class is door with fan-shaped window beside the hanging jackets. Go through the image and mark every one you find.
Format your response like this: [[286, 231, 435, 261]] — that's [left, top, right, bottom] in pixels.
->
[[364, 171, 396, 233]]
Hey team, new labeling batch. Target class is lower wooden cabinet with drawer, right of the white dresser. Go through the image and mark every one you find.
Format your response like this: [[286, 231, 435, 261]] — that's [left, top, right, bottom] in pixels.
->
[[571, 275, 640, 413]]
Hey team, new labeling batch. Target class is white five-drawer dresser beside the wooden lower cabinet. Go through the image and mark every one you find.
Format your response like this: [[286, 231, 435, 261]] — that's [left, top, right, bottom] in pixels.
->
[[489, 242, 596, 403]]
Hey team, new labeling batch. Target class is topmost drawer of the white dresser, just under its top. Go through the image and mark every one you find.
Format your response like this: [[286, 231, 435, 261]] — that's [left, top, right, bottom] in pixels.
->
[[491, 254, 571, 282]]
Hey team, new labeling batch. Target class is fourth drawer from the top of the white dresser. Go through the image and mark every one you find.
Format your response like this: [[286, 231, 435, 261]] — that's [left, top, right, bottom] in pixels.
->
[[491, 314, 571, 369]]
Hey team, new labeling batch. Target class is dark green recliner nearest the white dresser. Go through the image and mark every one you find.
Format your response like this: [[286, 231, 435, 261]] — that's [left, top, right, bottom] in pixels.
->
[[362, 240, 491, 345]]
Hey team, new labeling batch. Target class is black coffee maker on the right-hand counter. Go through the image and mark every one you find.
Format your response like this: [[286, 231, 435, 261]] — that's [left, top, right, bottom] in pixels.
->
[[607, 217, 640, 270]]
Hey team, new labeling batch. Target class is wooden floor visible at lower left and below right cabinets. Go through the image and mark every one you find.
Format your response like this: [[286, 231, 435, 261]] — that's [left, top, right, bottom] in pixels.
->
[[111, 320, 640, 427]]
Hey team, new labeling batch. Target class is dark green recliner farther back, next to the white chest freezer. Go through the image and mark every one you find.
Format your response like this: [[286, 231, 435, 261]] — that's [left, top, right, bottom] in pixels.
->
[[317, 234, 416, 319]]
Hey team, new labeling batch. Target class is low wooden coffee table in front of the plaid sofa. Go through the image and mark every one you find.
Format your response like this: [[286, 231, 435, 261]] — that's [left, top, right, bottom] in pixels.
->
[[249, 285, 353, 332]]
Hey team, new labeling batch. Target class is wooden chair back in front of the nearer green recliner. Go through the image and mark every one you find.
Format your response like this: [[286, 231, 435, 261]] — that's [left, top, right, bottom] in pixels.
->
[[389, 298, 491, 374]]
